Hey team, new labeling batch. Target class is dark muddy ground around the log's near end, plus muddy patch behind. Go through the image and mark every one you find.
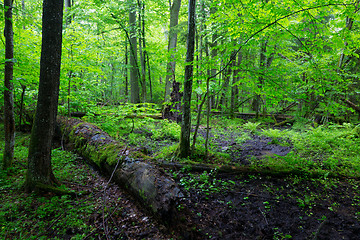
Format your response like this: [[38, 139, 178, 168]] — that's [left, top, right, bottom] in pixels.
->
[[72, 124, 360, 239]]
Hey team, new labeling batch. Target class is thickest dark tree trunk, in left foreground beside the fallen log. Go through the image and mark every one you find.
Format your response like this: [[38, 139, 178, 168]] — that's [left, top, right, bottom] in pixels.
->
[[25, 0, 64, 191]]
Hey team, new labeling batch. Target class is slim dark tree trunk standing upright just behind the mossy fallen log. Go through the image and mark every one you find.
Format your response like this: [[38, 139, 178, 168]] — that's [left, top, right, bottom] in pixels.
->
[[178, 0, 196, 158]]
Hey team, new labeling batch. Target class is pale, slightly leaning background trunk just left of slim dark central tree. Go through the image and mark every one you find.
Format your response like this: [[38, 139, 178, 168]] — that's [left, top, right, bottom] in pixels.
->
[[164, 0, 181, 102]]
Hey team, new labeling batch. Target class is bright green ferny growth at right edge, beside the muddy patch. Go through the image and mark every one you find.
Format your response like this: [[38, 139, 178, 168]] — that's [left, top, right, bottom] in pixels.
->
[[256, 123, 360, 176]]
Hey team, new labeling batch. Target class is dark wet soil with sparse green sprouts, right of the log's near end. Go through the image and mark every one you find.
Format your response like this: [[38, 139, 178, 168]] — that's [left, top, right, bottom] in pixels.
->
[[174, 173, 360, 239]]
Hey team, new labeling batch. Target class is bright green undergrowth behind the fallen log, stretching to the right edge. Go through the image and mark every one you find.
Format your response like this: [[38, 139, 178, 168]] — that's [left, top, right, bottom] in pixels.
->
[[85, 104, 360, 176]]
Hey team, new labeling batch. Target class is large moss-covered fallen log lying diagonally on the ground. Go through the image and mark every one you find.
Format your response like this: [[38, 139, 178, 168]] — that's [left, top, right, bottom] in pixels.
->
[[58, 117, 183, 221]]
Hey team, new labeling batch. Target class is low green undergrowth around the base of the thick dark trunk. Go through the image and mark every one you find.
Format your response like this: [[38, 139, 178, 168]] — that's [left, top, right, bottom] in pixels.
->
[[0, 131, 108, 239]]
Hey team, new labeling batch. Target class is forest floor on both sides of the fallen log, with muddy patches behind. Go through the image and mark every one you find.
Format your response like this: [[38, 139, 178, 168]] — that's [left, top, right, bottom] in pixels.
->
[[0, 117, 360, 239]]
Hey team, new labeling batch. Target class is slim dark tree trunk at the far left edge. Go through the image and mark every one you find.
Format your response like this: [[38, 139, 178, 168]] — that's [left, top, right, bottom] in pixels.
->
[[3, 0, 15, 170]]
